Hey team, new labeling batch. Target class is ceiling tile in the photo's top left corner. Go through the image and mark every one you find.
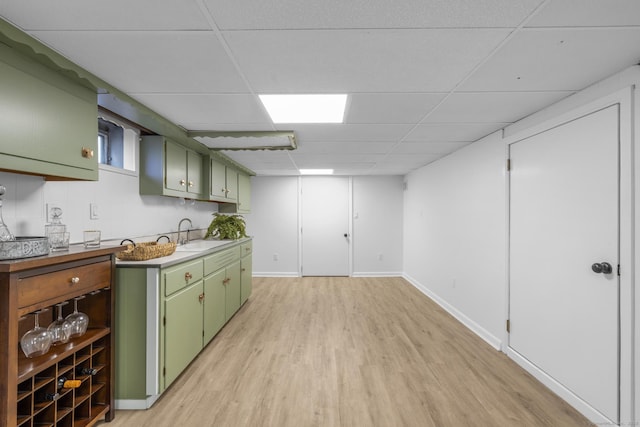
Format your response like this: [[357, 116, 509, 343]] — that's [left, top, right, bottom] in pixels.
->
[[0, 0, 210, 31]]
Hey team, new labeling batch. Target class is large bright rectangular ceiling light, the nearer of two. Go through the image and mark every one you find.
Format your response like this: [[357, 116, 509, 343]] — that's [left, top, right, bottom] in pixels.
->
[[260, 95, 347, 123]]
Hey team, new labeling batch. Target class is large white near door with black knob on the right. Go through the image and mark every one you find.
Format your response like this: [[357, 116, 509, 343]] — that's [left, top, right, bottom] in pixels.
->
[[509, 105, 619, 422]]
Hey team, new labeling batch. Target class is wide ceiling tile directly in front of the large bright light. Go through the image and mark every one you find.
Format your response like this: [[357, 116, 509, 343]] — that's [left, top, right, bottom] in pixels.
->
[[224, 29, 508, 93]]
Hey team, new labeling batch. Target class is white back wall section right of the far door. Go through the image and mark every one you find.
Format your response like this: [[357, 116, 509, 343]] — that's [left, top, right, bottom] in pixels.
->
[[352, 176, 403, 276]]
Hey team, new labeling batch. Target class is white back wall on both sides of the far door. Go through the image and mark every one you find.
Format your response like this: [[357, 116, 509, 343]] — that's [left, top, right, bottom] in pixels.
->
[[245, 176, 403, 276]]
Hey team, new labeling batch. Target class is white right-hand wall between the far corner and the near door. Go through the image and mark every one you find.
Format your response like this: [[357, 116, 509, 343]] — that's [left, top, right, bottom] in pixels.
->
[[403, 132, 506, 348]]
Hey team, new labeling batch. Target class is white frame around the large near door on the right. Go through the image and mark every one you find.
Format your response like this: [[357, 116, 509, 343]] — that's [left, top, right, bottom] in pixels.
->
[[502, 85, 640, 423]]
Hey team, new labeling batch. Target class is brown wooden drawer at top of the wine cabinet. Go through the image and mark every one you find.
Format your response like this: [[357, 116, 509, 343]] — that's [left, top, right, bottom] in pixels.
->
[[18, 261, 111, 308]]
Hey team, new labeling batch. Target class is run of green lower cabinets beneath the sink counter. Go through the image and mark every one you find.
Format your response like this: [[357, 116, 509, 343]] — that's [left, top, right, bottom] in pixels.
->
[[115, 240, 252, 409]]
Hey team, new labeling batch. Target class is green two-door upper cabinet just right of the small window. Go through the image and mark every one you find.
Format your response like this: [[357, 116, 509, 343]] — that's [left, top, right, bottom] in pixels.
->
[[140, 135, 203, 199]]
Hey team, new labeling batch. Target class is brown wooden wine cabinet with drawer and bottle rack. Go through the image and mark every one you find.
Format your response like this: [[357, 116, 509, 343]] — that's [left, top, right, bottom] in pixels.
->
[[0, 246, 123, 427]]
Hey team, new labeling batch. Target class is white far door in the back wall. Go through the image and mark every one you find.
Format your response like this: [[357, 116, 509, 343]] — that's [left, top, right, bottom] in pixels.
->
[[301, 176, 349, 276]]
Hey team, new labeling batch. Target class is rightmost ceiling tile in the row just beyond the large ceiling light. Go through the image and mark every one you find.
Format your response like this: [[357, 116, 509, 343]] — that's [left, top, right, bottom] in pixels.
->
[[404, 123, 507, 142]]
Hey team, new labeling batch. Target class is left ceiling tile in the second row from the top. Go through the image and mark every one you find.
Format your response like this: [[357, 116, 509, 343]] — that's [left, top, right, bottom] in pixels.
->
[[33, 31, 247, 93]]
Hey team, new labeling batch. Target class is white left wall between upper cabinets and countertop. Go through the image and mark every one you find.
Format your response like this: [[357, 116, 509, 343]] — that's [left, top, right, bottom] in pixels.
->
[[0, 170, 218, 243]]
